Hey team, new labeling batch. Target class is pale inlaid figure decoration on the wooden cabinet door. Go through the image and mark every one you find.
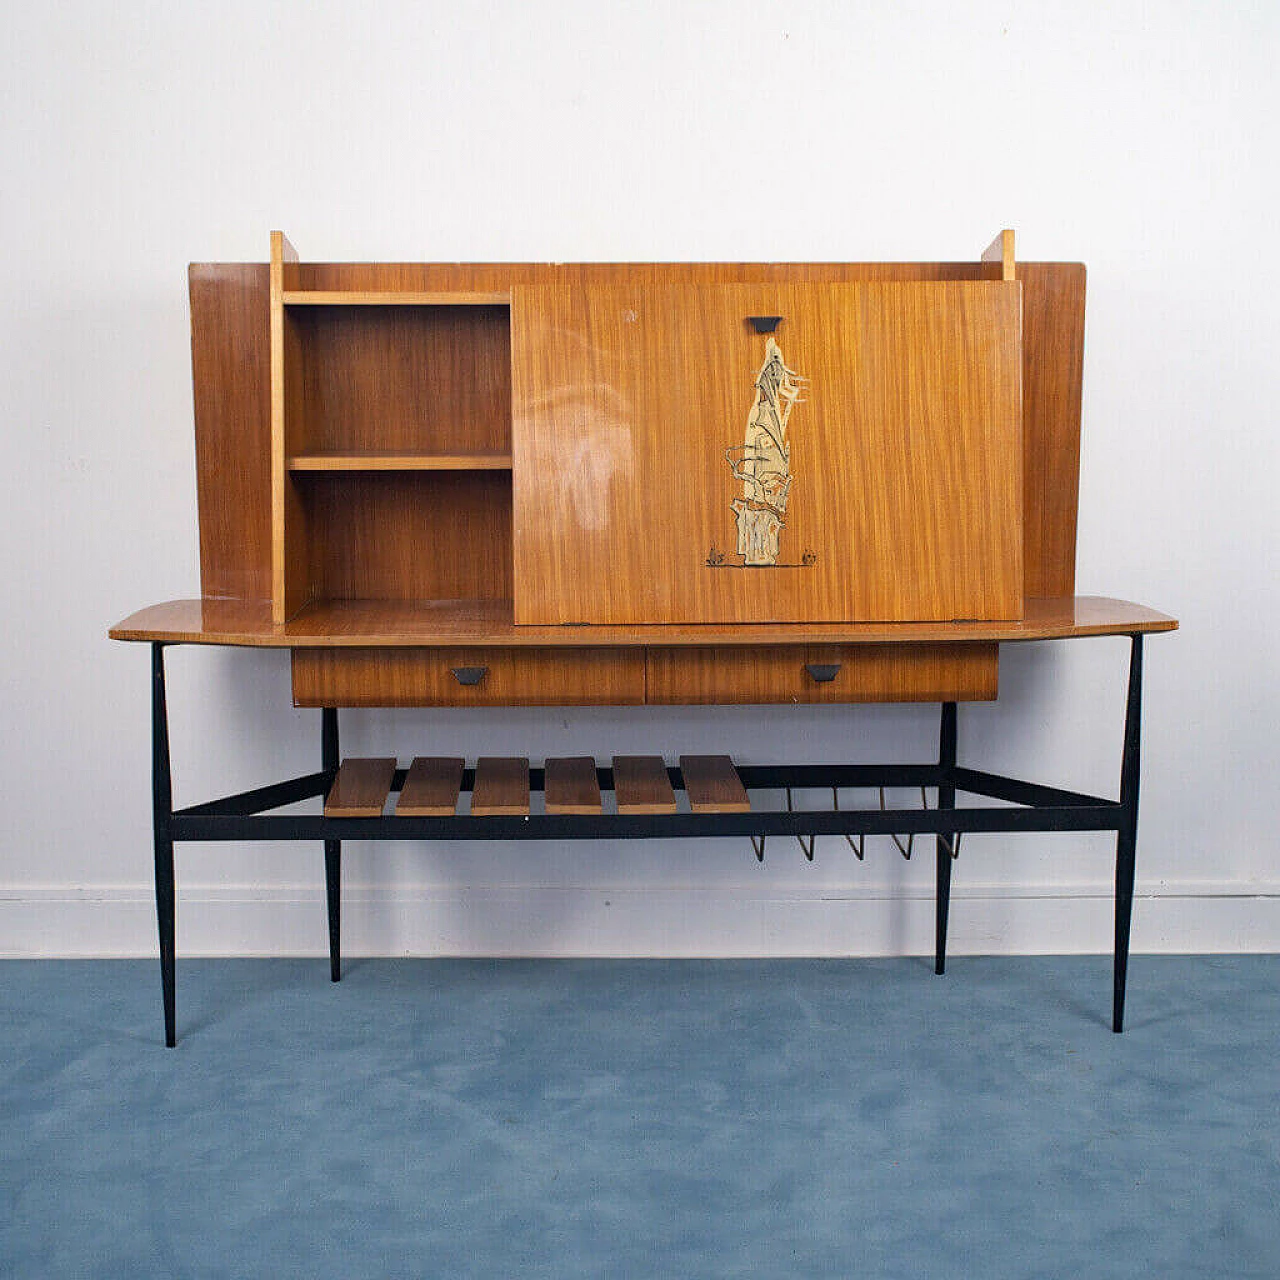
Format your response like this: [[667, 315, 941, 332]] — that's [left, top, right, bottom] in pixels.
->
[[707, 335, 817, 568]]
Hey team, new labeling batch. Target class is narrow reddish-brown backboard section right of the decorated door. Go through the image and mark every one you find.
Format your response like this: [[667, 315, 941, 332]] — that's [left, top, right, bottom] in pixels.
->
[[1018, 262, 1084, 596]]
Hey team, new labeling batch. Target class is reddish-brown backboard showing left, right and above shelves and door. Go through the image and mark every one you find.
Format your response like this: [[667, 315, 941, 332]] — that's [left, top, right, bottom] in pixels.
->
[[189, 261, 1085, 600]]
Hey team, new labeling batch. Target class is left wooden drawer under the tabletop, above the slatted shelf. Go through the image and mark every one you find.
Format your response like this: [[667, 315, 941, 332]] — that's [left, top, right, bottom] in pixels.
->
[[293, 649, 645, 707]]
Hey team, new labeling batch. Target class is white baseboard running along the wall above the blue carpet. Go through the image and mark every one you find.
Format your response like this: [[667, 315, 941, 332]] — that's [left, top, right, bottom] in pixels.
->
[[0, 883, 1280, 959]]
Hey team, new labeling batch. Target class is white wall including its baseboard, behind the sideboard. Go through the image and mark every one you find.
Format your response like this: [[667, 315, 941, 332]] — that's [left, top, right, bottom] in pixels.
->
[[0, 0, 1280, 955]]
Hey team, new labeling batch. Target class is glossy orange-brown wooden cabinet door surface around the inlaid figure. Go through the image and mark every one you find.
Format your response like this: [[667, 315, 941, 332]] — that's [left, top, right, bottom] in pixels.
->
[[511, 283, 1023, 623]]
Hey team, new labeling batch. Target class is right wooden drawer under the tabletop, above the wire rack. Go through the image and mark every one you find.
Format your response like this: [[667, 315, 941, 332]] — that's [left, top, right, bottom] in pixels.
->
[[646, 643, 1000, 704]]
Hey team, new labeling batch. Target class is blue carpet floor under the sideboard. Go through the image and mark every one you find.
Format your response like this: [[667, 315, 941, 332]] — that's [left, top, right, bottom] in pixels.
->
[[0, 956, 1280, 1280]]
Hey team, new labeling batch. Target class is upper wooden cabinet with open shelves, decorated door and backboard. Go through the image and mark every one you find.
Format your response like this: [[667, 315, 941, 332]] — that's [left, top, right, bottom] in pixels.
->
[[232, 232, 1049, 639]]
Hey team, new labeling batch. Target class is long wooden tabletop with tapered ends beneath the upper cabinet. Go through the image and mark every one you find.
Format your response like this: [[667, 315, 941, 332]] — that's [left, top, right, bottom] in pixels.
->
[[109, 595, 1178, 649]]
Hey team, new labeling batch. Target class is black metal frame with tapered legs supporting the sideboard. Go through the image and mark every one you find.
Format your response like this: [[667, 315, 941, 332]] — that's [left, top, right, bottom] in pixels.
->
[[151, 634, 1142, 1047]]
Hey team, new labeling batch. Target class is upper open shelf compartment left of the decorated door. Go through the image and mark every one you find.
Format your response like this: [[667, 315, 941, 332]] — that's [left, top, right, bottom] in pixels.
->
[[288, 306, 511, 453]]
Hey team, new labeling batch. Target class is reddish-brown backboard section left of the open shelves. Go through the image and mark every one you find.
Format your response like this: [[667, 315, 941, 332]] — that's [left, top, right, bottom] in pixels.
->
[[188, 262, 271, 600]]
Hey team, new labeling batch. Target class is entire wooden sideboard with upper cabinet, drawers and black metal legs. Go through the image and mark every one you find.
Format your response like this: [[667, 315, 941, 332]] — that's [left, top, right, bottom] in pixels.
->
[[110, 232, 1176, 1046]]
